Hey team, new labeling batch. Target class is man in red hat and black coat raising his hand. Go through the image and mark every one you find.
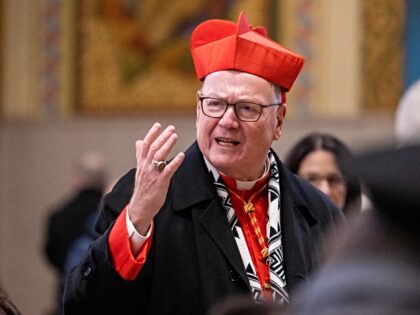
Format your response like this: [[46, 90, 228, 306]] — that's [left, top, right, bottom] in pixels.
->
[[65, 13, 341, 314]]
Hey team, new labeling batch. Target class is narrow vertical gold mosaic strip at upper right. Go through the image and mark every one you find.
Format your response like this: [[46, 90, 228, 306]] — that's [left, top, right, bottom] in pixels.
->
[[360, 0, 405, 112]]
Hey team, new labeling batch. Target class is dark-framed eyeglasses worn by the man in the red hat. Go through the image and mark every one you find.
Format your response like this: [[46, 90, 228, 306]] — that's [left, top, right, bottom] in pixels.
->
[[199, 96, 281, 122]]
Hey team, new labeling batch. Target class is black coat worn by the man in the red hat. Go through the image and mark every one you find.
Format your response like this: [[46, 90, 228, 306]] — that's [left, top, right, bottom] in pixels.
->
[[65, 143, 342, 314]]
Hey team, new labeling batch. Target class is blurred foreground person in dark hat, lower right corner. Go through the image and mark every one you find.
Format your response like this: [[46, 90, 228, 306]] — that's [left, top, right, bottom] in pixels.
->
[[287, 145, 420, 315]]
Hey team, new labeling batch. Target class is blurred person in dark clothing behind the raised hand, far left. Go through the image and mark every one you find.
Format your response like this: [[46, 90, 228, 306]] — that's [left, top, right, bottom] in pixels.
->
[[44, 151, 108, 309]]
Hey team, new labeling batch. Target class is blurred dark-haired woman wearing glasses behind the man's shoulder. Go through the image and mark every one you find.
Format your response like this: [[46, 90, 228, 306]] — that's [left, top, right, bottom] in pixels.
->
[[285, 133, 361, 216]]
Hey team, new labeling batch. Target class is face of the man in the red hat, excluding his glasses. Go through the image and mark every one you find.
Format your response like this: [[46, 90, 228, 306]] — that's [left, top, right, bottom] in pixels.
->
[[196, 71, 286, 180]]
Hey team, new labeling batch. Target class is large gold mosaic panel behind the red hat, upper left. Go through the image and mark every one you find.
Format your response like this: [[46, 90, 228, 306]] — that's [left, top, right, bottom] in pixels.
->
[[76, 0, 269, 113]]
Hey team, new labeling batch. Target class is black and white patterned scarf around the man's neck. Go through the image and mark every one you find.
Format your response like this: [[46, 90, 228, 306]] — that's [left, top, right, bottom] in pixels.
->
[[206, 152, 289, 304]]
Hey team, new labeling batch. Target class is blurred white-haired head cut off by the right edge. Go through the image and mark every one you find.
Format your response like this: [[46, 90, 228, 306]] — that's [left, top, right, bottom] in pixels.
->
[[395, 80, 420, 146]]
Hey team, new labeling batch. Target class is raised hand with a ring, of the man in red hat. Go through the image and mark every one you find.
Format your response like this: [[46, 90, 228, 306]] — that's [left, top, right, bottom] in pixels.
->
[[128, 123, 185, 235]]
